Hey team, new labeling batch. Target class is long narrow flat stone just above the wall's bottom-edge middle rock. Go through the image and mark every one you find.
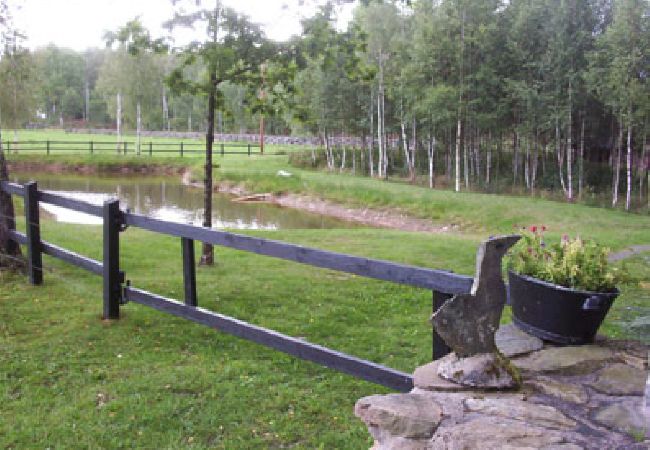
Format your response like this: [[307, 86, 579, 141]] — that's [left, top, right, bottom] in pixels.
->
[[464, 397, 577, 430]]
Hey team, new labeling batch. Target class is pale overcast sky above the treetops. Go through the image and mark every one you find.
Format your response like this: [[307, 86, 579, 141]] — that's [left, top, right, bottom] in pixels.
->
[[10, 0, 352, 50]]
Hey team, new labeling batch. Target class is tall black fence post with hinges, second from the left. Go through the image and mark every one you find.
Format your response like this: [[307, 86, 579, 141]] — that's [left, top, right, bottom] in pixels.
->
[[103, 200, 122, 320]]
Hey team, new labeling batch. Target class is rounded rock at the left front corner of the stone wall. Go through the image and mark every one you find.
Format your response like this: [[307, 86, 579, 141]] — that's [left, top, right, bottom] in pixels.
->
[[354, 394, 442, 440]]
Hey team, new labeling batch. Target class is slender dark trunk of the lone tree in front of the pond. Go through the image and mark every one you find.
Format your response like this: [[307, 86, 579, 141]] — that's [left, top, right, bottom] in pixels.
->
[[201, 70, 217, 266]]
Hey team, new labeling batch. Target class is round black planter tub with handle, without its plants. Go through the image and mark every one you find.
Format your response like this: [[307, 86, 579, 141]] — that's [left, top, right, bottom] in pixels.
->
[[508, 272, 619, 345]]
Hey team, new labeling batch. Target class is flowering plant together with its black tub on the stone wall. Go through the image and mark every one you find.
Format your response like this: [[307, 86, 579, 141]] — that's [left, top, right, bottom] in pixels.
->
[[506, 227, 628, 345]]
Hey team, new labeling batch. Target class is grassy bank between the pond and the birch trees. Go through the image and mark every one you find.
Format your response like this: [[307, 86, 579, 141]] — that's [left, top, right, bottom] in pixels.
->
[[209, 156, 650, 249]]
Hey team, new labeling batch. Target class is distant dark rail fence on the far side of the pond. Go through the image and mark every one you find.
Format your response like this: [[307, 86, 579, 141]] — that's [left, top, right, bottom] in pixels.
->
[[2, 140, 261, 158]]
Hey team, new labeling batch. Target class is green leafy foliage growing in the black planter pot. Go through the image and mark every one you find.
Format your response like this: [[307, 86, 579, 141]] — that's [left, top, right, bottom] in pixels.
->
[[505, 227, 631, 292]]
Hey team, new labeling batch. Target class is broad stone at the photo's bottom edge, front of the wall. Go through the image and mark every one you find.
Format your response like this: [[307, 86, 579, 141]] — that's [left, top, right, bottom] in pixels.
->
[[431, 417, 566, 450]]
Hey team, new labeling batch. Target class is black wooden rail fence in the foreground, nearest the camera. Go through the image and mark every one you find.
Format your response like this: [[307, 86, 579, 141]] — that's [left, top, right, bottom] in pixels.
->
[[0, 182, 473, 392]]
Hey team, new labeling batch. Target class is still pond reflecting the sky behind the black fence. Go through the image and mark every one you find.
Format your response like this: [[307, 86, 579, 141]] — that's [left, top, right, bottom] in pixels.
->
[[11, 172, 355, 230]]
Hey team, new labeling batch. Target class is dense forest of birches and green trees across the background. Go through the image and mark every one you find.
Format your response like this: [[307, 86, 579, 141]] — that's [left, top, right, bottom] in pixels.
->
[[0, 0, 650, 209]]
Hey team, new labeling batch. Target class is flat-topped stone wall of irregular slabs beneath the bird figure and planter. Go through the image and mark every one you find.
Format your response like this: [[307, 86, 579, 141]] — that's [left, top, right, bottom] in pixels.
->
[[355, 325, 650, 450]]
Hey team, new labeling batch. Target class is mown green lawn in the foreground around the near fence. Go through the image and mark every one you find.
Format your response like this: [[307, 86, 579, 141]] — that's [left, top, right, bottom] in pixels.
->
[[0, 206, 650, 449]]
